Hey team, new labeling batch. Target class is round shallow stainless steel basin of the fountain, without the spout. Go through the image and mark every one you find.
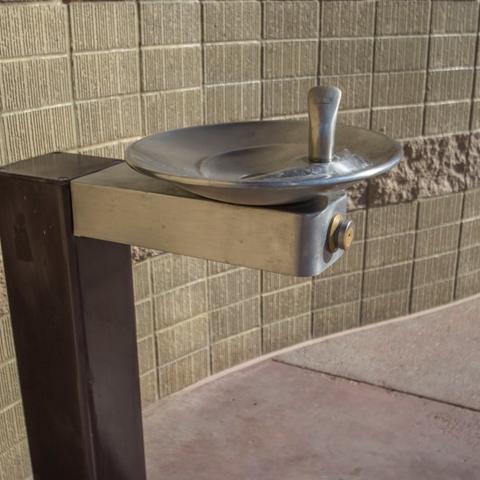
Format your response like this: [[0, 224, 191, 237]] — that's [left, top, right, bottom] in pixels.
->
[[127, 120, 402, 205]]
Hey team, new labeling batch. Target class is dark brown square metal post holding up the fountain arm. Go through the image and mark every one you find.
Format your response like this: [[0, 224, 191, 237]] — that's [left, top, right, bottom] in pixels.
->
[[0, 153, 146, 480]]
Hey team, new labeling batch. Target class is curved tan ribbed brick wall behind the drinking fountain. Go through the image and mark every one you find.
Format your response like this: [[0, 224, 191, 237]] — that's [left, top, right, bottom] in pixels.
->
[[0, 0, 480, 480]]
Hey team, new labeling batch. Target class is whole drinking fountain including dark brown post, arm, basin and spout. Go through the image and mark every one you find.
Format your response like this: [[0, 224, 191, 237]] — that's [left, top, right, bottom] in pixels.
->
[[0, 87, 402, 480]]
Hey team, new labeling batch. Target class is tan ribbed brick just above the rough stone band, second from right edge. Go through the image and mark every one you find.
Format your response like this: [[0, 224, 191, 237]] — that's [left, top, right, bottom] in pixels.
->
[[425, 100, 470, 135]]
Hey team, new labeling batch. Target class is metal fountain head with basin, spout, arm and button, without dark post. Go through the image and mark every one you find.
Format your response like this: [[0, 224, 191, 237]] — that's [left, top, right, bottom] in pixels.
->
[[72, 87, 402, 276]]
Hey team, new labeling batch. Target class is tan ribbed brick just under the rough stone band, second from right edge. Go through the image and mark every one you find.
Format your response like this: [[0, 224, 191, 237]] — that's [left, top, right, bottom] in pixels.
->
[[417, 193, 463, 230]]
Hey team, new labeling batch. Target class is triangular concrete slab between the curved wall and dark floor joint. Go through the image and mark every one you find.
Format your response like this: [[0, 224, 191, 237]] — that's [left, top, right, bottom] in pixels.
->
[[275, 296, 480, 411]]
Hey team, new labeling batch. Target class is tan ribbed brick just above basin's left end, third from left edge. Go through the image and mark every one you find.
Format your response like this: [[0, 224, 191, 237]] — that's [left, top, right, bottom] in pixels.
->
[[142, 88, 203, 135]]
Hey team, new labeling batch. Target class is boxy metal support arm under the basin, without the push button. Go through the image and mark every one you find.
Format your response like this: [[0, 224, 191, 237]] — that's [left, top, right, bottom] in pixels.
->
[[71, 164, 347, 276]]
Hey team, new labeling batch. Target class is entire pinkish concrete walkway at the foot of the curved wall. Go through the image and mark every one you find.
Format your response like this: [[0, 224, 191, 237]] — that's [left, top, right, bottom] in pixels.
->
[[145, 297, 480, 480]]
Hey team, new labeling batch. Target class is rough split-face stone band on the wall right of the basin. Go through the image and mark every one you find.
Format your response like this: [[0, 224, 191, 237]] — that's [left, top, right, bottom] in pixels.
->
[[368, 134, 468, 206]]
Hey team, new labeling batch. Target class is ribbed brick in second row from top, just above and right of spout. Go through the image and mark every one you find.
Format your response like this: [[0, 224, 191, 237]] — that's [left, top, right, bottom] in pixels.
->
[[320, 38, 373, 75]]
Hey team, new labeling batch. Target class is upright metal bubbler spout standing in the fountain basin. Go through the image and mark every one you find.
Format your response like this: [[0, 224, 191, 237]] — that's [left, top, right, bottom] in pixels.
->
[[308, 86, 342, 163]]
